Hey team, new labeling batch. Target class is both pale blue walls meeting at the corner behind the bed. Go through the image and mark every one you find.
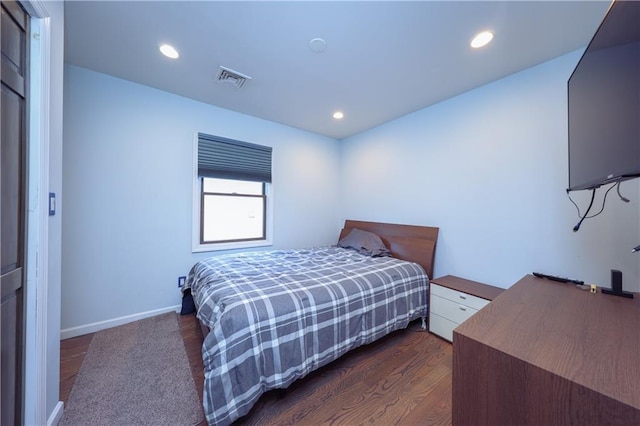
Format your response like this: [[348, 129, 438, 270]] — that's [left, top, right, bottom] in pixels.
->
[[62, 52, 640, 332]]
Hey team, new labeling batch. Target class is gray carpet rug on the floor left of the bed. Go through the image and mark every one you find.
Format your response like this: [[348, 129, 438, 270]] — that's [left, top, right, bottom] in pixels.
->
[[60, 312, 204, 425]]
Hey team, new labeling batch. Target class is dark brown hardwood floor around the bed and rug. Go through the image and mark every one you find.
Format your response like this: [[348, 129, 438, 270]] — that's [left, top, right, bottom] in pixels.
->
[[60, 315, 452, 425]]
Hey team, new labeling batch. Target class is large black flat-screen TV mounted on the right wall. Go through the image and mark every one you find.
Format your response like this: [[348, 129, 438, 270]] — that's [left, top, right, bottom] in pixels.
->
[[568, 0, 640, 191]]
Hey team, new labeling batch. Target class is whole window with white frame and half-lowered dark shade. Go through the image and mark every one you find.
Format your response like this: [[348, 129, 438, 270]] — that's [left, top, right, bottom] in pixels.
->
[[193, 133, 272, 251]]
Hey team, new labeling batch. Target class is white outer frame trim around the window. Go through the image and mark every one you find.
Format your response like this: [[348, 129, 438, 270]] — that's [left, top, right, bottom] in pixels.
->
[[191, 132, 273, 253]]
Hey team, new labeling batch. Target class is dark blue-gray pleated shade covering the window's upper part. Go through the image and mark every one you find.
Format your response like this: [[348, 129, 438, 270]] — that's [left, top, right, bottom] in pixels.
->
[[198, 133, 272, 183]]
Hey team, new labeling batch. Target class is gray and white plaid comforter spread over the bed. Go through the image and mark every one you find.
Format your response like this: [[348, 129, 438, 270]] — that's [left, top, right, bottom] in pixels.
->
[[185, 247, 429, 424]]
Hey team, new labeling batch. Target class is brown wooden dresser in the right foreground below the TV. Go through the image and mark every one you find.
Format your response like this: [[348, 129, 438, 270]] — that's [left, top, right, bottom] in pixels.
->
[[452, 275, 640, 426]]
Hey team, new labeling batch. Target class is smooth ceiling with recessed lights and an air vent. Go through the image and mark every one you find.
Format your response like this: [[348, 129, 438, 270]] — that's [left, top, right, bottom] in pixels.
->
[[65, 1, 609, 139]]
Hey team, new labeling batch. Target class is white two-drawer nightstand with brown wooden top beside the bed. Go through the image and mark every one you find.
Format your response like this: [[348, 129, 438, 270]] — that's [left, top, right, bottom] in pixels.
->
[[429, 275, 504, 342]]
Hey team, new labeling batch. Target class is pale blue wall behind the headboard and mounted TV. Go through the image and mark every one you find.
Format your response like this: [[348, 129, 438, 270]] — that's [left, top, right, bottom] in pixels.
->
[[341, 52, 640, 291]]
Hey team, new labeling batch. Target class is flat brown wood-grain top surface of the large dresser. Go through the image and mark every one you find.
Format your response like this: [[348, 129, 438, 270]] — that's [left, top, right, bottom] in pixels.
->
[[453, 275, 640, 408]]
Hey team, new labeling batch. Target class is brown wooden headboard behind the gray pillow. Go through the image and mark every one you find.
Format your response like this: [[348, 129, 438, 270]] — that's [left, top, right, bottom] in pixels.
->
[[340, 220, 439, 279]]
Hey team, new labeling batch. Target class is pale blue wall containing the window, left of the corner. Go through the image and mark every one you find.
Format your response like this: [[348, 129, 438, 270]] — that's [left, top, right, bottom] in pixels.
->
[[62, 65, 340, 333]]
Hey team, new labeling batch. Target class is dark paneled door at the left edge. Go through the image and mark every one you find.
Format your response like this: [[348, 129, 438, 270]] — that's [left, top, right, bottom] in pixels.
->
[[0, 0, 28, 426]]
